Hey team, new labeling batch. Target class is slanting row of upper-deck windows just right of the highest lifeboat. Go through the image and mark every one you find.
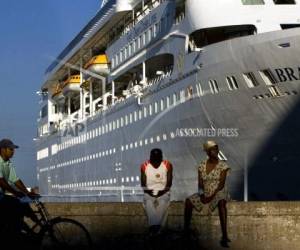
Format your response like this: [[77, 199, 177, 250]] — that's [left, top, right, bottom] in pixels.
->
[[112, 16, 169, 68]]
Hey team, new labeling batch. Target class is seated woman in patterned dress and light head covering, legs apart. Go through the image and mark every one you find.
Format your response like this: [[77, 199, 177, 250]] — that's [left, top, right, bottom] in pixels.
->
[[184, 141, 230, 247]]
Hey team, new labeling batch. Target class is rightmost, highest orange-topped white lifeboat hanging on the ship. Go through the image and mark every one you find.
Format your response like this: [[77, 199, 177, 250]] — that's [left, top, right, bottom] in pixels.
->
[[84, 54, 109, 76]]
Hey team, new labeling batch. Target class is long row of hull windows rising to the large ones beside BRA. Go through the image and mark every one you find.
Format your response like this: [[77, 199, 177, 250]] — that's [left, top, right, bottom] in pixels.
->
[[50, 69, 277, 154]]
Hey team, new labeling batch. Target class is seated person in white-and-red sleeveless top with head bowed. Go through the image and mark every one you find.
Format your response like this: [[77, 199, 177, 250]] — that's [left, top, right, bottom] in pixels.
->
[[141, 148, 173, 235]]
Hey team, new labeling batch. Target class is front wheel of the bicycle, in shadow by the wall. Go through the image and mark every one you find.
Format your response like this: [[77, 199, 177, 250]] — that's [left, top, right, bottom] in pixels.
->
[[41, 217, 92, 250]]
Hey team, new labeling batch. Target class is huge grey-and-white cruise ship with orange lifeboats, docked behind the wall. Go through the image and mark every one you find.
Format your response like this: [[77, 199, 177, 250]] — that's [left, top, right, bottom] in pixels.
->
[[35, 0, 300, 202]]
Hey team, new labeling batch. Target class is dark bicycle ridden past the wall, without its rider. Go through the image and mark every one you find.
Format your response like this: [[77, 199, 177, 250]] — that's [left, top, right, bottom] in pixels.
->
[[22, 197, 92, 250]]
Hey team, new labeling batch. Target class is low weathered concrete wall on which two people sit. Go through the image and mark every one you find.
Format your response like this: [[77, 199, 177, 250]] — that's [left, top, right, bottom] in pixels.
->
[[39, 202, 300, 250]]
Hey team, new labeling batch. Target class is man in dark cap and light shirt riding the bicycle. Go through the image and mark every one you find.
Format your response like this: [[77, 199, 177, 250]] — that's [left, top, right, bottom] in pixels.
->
[[0, 139, 36, 238]]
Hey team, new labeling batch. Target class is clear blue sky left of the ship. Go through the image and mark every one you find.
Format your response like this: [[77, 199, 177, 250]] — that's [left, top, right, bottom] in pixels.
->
[[0, 0, 101, 186]]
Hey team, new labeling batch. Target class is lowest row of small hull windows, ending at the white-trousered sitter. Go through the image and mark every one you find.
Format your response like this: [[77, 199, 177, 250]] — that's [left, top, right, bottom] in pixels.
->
[[52, 176, 140, 188]]
